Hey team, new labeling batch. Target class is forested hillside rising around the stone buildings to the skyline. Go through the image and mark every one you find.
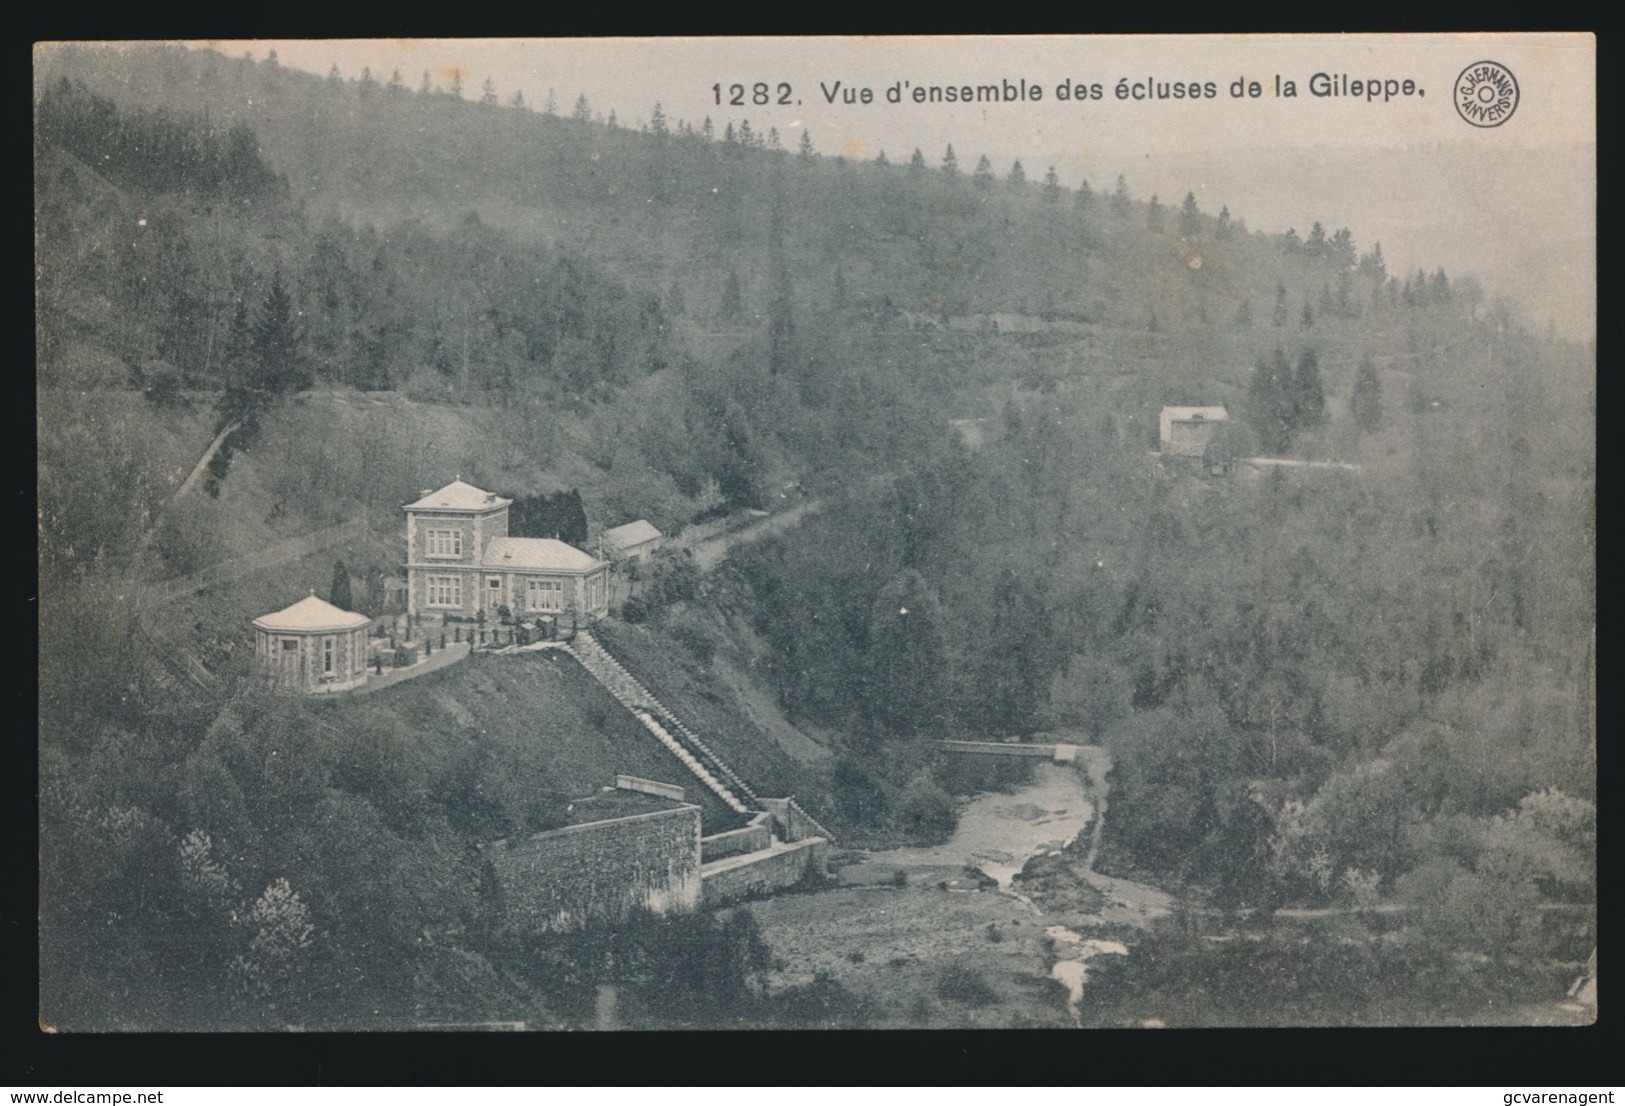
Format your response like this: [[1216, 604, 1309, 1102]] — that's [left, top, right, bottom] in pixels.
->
[[34, 47, 1596, 1023]]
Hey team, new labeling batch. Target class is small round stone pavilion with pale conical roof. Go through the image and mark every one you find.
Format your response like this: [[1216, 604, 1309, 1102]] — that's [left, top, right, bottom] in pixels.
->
[[254, 591, 372, 695]]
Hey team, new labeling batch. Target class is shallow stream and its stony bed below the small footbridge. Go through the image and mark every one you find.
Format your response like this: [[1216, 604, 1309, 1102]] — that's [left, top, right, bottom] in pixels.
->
[[749, 747, 1172, 1028]]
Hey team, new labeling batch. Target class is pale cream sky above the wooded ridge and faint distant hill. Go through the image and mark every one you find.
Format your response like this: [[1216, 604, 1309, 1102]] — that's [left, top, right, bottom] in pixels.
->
[[221, 36, 1596, 164]]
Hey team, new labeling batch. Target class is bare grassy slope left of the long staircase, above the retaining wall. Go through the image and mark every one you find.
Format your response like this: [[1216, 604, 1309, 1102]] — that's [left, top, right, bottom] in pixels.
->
[[315, 653, 738, 833]]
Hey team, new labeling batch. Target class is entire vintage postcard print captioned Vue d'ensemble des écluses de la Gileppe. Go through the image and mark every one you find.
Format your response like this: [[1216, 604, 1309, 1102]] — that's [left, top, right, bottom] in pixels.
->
[[33, 34, 1597, 1033]]
